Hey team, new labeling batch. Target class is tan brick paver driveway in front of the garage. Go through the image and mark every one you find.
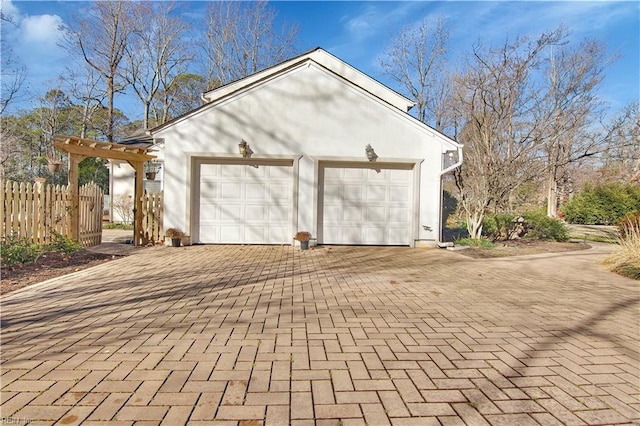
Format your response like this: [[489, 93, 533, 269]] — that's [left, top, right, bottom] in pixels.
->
[[2, 246, 640, 425]]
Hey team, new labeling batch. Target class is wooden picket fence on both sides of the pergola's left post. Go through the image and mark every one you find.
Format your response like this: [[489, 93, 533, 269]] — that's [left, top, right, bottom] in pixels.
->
[[0, 182, 104, 247]]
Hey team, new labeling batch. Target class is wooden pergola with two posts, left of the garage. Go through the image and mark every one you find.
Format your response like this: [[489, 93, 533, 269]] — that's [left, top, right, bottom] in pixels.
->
[[52, 135, 156, 246]]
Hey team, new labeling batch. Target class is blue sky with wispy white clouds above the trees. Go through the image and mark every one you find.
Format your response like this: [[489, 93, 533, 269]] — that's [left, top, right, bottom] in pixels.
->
[[2, 0, 640, 120]]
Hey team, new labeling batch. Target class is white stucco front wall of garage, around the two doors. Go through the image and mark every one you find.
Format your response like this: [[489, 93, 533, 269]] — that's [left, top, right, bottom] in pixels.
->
[[154, 63, 454, 245]]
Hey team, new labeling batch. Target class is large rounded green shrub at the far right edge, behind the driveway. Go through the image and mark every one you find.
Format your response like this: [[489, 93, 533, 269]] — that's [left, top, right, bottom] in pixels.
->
[[561, 184, 640, 225]]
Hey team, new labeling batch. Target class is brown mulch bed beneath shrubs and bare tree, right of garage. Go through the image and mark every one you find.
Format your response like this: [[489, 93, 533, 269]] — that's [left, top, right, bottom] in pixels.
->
[[458, 240, 591, 259]]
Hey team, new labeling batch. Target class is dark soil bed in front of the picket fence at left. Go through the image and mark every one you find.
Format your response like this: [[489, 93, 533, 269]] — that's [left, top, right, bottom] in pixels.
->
[[0, 250, 121, 294]]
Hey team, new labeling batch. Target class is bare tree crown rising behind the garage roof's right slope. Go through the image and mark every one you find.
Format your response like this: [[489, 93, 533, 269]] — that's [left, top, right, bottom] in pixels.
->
[[380, 18, 449, 130]]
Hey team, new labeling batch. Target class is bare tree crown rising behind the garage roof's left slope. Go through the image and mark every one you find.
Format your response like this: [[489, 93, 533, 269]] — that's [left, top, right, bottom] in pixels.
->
[[201, 0, 299, 89]]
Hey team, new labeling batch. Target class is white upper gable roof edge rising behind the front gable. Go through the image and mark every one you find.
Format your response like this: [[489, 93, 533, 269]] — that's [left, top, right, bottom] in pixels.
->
[[202, 47, 415, 112]]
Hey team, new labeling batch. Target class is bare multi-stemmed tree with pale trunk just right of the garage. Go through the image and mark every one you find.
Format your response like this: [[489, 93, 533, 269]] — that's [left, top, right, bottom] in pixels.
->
[[454, 29, 563, 238]]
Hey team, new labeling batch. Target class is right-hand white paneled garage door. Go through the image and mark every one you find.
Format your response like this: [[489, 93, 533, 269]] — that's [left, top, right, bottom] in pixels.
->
[[322, 167, 413, 245]]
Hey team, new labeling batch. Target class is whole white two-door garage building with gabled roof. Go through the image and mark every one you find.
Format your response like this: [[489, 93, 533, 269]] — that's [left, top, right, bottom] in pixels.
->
[[151, 49, 462, 246]]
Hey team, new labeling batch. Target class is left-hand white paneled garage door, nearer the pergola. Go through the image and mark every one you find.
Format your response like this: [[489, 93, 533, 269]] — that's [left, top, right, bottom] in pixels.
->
[[199, 164, 293, 244]]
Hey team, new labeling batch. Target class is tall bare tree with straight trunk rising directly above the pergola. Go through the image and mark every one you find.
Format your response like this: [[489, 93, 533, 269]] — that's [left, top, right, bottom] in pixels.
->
[[62, 0, 140, 142]]
